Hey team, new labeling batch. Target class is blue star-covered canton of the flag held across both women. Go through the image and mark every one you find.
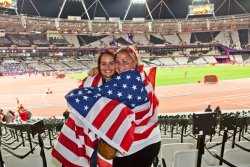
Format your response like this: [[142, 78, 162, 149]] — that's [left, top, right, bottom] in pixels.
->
[[65, 70, 149, 117]]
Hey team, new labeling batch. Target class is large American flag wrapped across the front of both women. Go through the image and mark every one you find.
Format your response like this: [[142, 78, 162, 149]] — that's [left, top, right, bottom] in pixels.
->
[[52, 66, 158, 167]]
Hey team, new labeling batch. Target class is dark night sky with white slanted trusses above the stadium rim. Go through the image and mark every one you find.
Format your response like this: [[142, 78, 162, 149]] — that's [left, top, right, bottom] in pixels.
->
[[1, 0, 250, 20]]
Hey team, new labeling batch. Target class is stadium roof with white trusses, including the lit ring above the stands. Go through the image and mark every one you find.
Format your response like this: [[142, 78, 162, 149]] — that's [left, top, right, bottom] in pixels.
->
[[0, 0, 250, 34]]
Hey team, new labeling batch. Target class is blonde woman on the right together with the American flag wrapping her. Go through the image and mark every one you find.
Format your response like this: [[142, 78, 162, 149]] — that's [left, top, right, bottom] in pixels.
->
[[52, 47, 160, 167]]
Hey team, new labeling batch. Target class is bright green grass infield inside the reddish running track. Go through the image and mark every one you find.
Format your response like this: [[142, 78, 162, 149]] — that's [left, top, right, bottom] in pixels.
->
[[67, 66, 250, 86]]
